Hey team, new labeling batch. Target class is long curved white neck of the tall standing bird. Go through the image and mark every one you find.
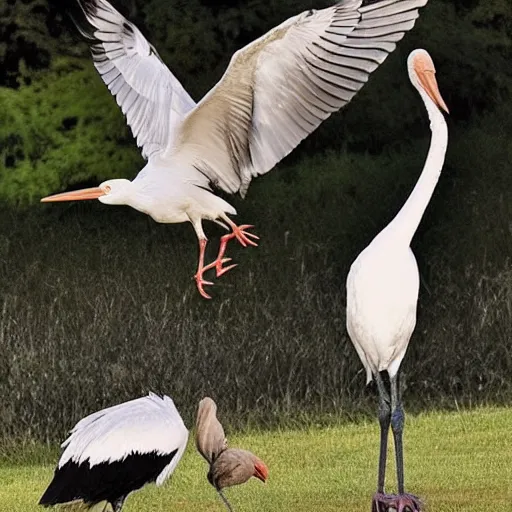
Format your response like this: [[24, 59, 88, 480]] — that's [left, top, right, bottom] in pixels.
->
[[386, 92, 448, 246]]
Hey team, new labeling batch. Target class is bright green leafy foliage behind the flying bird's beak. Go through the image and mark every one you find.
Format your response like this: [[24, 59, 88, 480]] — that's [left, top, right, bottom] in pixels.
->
[[0, 59, 142, 204]]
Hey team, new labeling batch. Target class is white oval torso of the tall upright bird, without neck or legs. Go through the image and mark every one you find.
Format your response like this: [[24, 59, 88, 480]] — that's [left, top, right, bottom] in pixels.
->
[[347, 236, 419, 381]]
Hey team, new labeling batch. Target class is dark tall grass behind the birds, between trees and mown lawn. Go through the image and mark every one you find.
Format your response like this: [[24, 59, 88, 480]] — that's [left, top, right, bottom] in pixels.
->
[[0, 106, 512, 440]]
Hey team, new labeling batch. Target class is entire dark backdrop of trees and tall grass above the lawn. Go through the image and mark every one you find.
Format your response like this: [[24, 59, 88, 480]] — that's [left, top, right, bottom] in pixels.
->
[[0, 0, 512, 440]]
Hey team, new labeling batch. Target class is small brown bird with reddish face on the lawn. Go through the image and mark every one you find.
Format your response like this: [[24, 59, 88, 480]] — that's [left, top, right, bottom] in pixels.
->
[[196, 397, 268, 512]]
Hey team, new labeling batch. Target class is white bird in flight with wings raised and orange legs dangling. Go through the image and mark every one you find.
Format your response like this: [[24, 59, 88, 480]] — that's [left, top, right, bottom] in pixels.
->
[[42, 0, 427, 298]]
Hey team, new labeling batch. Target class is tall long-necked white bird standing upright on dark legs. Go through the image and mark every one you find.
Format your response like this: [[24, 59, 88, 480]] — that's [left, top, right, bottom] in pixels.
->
[[347, 50, 448, 512]]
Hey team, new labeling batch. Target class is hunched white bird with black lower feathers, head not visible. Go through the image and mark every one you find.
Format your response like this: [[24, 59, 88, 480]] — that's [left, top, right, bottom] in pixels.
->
[[39, 393, 188, 512]]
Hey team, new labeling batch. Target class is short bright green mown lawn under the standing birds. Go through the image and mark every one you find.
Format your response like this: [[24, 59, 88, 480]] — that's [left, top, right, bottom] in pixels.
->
[[0, 409, 512, 512]]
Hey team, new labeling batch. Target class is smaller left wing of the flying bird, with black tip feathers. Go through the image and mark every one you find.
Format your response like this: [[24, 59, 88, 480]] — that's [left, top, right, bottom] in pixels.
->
[[75, 0, 195, 158]]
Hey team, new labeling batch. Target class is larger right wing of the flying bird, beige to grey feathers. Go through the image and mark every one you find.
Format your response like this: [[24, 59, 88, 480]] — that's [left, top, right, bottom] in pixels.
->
[[173, 0, 427, 196]]
